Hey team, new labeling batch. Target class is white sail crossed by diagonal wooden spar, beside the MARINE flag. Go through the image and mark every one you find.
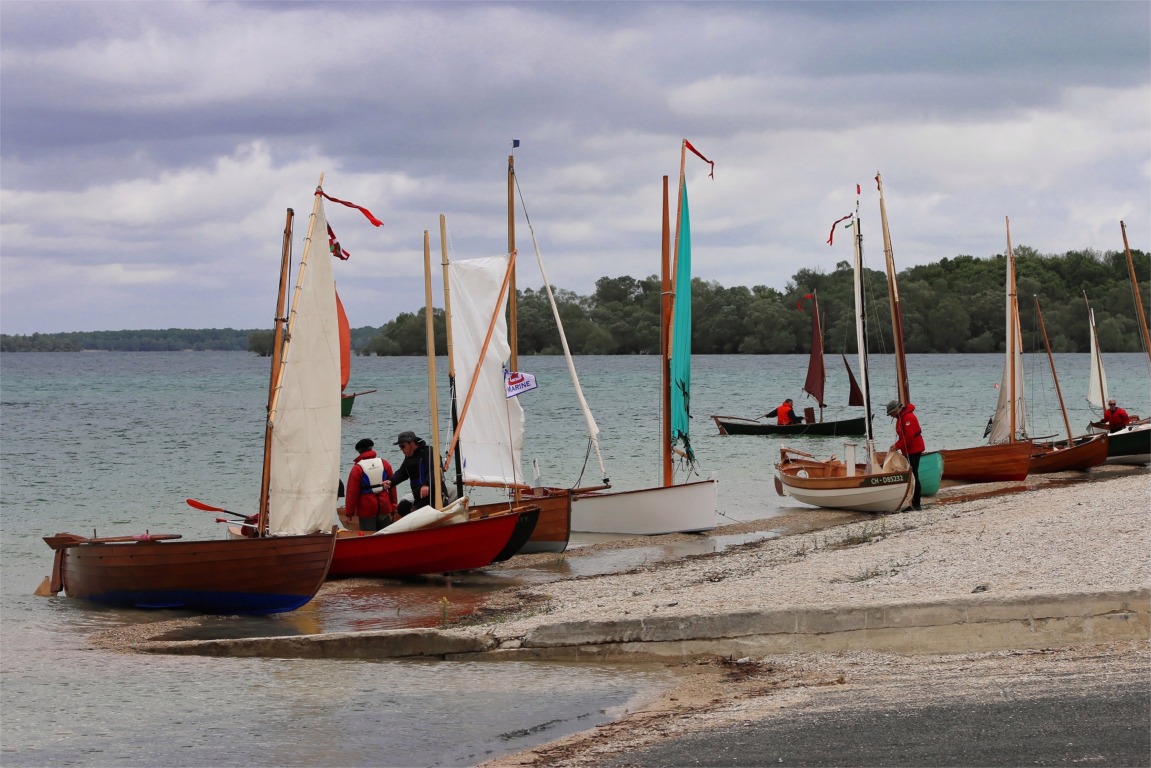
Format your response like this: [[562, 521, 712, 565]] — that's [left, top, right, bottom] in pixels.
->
[[448, 256, 524, 484]]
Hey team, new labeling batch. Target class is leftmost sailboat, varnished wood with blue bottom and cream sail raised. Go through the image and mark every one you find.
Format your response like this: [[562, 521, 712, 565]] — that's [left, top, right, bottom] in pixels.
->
[[45, 191, 340, 614]]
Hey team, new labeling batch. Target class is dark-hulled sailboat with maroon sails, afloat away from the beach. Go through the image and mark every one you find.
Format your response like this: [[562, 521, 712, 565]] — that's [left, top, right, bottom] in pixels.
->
[[711, 291, 867, 438]]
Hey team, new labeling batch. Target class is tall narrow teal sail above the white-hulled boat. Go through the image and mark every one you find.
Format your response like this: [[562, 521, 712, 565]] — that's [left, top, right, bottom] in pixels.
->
[[670, 181, 695, 464]]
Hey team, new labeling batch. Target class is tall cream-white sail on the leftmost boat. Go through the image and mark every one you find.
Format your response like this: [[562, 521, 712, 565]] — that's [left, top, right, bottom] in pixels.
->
[[268, 196, 341, 535]]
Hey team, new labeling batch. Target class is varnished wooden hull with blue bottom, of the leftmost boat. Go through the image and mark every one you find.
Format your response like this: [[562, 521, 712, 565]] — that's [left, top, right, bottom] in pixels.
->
[[46, 533, 336, 614]]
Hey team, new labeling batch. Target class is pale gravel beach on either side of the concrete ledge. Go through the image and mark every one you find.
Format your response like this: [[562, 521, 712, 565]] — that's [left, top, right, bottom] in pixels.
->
[[474, 466, 1151, 768]]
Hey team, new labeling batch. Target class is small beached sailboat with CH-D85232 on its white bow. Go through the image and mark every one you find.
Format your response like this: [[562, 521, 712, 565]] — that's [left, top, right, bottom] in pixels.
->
[[775, 192, 915, 512]]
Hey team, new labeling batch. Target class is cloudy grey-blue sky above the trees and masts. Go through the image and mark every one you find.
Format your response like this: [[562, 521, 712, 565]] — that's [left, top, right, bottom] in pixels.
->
[[0, 0, 1151, 334]]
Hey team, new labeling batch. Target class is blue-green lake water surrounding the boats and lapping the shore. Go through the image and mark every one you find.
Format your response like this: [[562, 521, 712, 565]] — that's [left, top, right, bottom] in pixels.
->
[[0, 352, 1151, 766]]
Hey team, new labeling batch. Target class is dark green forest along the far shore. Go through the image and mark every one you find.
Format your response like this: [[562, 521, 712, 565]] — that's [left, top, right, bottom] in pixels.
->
[[0, 246, 1151, 356]]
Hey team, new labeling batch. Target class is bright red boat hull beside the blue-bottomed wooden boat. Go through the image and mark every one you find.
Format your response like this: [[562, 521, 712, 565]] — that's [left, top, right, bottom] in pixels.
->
[[328, 509, 539, 578]]
